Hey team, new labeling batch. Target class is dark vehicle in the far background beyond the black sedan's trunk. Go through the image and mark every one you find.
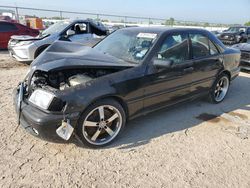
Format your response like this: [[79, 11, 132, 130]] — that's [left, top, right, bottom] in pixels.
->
[[218, 26, 250, 45]]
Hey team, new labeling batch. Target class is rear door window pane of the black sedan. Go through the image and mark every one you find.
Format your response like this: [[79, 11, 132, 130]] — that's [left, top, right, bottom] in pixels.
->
[[190, 34, 210, 59]]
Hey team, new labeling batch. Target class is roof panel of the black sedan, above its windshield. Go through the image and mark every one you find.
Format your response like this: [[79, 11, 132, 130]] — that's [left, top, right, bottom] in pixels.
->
[[122, 26, 210, 34]]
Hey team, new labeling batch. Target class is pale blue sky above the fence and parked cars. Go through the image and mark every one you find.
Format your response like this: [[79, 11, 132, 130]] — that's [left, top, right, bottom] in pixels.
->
[[0, 0, 250, 24]]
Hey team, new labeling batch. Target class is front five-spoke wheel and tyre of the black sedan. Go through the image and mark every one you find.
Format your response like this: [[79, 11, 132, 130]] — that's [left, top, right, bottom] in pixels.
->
[[77, 99, 126, 147]]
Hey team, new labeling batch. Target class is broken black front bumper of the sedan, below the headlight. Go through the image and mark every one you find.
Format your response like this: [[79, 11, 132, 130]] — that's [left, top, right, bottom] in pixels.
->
[[13, 88, 78, 142]]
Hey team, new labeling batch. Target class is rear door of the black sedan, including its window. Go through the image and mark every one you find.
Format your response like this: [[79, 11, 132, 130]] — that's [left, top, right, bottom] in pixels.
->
[[189, 32, 223, 94]]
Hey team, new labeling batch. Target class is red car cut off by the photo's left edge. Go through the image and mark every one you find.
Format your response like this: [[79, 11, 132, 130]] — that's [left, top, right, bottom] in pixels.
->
[[0, 21, 39, 49]]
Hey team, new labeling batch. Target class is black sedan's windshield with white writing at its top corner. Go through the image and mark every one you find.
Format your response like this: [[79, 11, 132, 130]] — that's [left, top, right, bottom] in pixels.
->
[[94, 30, 157, 63]]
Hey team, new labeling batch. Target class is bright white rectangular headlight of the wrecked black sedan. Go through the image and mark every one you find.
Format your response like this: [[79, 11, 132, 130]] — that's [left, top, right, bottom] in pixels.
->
[[29, 89, 55, 110]]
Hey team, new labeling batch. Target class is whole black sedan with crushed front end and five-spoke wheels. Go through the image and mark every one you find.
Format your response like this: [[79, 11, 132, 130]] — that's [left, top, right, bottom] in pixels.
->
[[14, 27, 240, 147]]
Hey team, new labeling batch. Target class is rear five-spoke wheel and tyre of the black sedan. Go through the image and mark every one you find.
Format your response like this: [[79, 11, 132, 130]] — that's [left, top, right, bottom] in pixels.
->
[[209, 73, 230, 103]]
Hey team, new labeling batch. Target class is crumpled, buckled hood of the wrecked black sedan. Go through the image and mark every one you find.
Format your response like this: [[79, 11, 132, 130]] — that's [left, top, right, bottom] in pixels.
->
[[31, 41, 136, 72]]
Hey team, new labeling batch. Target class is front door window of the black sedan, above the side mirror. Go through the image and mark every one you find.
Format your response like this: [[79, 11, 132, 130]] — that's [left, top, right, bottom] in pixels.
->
[[157, 34, 189, 64]]
